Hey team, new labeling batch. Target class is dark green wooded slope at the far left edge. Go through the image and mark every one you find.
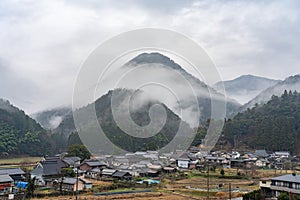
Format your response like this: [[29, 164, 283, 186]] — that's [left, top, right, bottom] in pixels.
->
[[0, 99, 54, 156]]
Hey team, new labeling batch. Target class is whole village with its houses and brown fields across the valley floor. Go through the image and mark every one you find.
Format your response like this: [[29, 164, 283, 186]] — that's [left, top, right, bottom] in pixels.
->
[[0, 147, 300, 199]]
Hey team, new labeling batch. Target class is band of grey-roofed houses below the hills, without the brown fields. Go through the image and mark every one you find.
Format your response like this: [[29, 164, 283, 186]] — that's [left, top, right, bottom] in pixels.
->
[[0, 148, 293, 197]]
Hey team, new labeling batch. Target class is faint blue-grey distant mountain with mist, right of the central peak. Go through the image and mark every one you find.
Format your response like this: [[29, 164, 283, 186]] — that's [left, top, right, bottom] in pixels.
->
[[213, 75, 280, 104]]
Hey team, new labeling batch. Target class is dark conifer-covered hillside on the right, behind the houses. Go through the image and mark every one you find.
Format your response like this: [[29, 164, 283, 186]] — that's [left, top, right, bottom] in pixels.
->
[[219, 91, 300, 154]]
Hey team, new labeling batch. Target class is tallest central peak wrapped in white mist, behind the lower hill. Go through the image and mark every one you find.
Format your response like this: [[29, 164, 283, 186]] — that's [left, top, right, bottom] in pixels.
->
[[112, 52, 240, 127]]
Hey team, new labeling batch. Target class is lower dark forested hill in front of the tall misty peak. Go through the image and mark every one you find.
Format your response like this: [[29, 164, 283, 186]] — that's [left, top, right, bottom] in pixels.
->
[[55, 89, 192, 152]]
